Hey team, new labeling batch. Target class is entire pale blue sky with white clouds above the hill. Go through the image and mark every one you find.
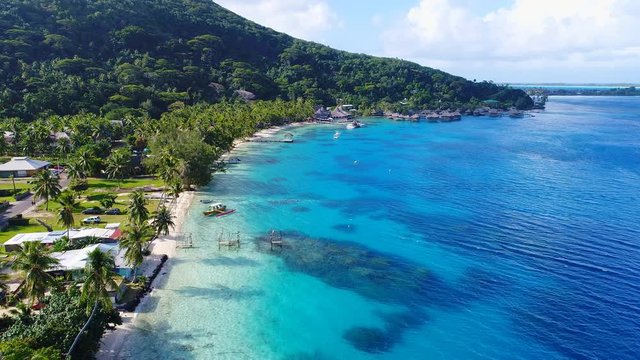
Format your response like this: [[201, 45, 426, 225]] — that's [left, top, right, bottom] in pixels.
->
[[215, 0, 640, 84]]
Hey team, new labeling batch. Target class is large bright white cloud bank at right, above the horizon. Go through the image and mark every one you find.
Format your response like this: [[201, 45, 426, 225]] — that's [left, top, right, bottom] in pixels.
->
[[382, 0, 640, 81]]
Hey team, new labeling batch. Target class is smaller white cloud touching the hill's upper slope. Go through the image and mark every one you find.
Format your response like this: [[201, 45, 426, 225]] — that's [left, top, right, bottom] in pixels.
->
[[216, 0, 340, 41]]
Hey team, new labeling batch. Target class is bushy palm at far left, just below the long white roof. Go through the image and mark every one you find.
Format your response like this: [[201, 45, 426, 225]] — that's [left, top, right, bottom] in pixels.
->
[[11, 241, 58, 304]]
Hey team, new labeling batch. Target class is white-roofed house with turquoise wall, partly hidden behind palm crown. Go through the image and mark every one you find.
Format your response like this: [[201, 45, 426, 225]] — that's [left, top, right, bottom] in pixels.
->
[[51, 244, 133, 279]]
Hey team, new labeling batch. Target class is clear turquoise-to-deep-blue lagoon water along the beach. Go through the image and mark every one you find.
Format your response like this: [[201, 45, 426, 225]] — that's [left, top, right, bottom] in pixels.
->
[[122, 97, 640, 359]]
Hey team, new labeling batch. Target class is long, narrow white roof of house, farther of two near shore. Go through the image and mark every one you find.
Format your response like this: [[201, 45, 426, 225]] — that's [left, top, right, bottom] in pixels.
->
[[3, 228, 122, 252]]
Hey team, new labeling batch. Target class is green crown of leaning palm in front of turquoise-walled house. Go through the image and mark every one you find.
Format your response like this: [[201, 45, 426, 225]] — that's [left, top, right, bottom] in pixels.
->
[[81, 249, 118, 313]]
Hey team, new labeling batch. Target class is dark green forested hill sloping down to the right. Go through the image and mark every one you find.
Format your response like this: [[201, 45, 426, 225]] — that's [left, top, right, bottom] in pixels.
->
[[0, 0, 532, 120]]
